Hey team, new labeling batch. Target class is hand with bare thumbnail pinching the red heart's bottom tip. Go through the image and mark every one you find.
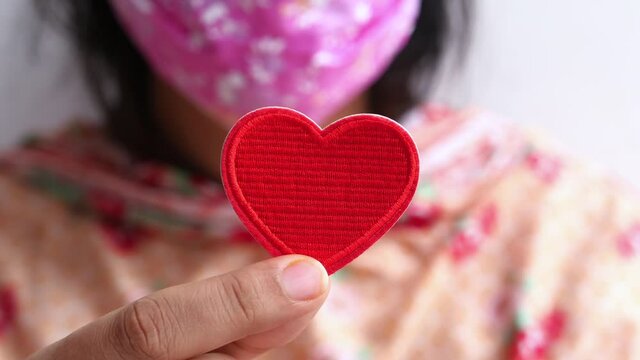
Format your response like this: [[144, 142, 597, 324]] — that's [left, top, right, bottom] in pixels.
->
[[30, 255, 329, 360]]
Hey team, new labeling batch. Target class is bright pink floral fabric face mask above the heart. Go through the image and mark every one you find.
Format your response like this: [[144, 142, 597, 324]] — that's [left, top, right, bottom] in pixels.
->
[[111, 0, 420, 126]]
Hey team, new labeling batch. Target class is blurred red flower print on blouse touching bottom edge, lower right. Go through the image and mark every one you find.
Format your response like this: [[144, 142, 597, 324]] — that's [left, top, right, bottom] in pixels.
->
[[511, 310, 567, 360]]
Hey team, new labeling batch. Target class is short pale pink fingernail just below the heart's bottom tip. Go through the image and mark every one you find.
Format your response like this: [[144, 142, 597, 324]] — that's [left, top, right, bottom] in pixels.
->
[[280, 260, 328, 301]]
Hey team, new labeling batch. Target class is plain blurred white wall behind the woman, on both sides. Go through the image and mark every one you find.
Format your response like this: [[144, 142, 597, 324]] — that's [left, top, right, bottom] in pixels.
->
[[0, 0, 640, 185]]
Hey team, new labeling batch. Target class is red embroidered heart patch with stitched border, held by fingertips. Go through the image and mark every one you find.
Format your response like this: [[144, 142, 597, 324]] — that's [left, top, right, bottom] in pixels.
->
[[222, 107, 419, 274]]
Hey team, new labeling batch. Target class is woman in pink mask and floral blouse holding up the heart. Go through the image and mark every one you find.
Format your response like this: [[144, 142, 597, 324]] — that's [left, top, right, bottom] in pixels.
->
[[0, 0, 640, 360]]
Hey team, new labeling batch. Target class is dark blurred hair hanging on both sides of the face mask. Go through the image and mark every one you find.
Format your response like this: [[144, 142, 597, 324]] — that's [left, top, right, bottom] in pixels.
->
[[34, 0, 472, 160]]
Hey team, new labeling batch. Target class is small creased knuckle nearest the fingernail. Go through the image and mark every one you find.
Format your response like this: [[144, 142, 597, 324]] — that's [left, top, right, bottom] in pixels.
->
[[219, 274, 258, 327]]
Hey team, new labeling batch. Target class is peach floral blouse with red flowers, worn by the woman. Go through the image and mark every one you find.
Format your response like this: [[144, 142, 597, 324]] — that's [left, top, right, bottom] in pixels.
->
[[0, 106, 640, 360]]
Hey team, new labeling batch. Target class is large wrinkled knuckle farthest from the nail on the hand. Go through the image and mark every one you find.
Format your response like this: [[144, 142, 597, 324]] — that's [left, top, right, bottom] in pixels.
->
[[117, 298, 168, 360]]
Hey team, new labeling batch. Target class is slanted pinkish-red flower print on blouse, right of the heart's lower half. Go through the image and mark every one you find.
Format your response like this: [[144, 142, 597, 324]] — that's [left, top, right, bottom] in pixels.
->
[[450, 204, 498, 263]]
